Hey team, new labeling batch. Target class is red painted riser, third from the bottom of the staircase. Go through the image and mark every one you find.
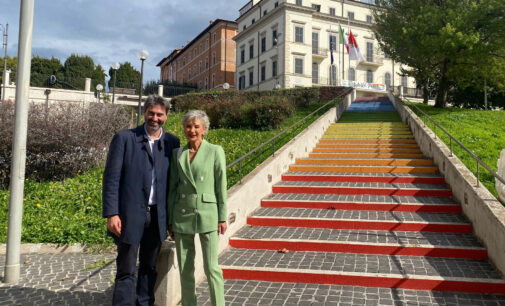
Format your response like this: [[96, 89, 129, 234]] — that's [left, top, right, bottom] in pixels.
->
[[247, 217, 473, 234]]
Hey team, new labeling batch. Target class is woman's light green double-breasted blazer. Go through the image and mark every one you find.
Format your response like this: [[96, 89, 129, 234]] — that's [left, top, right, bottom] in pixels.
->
[[168, 139, 227, 234]]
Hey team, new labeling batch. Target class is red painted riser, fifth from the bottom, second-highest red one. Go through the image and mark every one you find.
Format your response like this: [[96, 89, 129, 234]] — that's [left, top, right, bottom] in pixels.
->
[[272, 186, 452, 197]]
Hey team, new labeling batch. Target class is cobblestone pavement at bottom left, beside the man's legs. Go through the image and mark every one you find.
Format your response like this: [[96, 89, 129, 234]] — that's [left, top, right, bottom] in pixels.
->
[[0, 254, 116, 306]]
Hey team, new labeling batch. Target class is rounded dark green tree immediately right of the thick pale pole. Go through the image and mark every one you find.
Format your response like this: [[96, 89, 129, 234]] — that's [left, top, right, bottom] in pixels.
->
[[30, 56, 64, 87]]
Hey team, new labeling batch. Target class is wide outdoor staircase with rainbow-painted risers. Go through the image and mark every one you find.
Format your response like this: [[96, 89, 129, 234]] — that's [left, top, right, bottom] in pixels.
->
[[198, 101, 505, 305]]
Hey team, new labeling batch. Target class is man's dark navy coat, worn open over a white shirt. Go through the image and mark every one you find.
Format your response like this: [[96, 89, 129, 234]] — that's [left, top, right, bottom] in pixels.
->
[[102, 125, 180, 245]]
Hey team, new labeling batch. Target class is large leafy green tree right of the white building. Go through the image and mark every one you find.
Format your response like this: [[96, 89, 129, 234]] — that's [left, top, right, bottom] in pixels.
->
[[374, 0, 505, 107]]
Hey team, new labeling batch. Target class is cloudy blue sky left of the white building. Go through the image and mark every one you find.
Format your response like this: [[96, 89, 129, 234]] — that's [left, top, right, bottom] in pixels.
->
[[0, 0, 243, 80]]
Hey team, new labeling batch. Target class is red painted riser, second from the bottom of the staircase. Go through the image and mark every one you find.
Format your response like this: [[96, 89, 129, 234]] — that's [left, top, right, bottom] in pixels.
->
[[229, 238, 487, 260]]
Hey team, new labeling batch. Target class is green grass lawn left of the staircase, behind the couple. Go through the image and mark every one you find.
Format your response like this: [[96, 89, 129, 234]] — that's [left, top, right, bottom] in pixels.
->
[[0, 100, 338, 245]]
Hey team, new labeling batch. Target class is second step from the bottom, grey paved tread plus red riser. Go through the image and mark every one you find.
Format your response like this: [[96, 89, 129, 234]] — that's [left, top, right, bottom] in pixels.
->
[[229, 226, 487, 260]]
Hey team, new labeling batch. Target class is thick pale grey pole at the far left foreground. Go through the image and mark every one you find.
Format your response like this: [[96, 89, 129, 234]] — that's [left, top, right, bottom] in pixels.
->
[[3, 0, 34, 283]]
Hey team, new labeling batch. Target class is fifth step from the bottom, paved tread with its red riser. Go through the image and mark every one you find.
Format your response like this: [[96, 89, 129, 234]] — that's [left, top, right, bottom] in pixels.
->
[[272, 181, 452, 197]]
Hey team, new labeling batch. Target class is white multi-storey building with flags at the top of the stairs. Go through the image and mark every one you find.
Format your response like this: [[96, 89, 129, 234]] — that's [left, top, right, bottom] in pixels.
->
[[234, 0, 415, 90]]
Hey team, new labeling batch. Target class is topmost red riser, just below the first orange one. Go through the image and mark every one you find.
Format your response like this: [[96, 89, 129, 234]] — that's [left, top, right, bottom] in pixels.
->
[[282, 174, 445, 184]]
